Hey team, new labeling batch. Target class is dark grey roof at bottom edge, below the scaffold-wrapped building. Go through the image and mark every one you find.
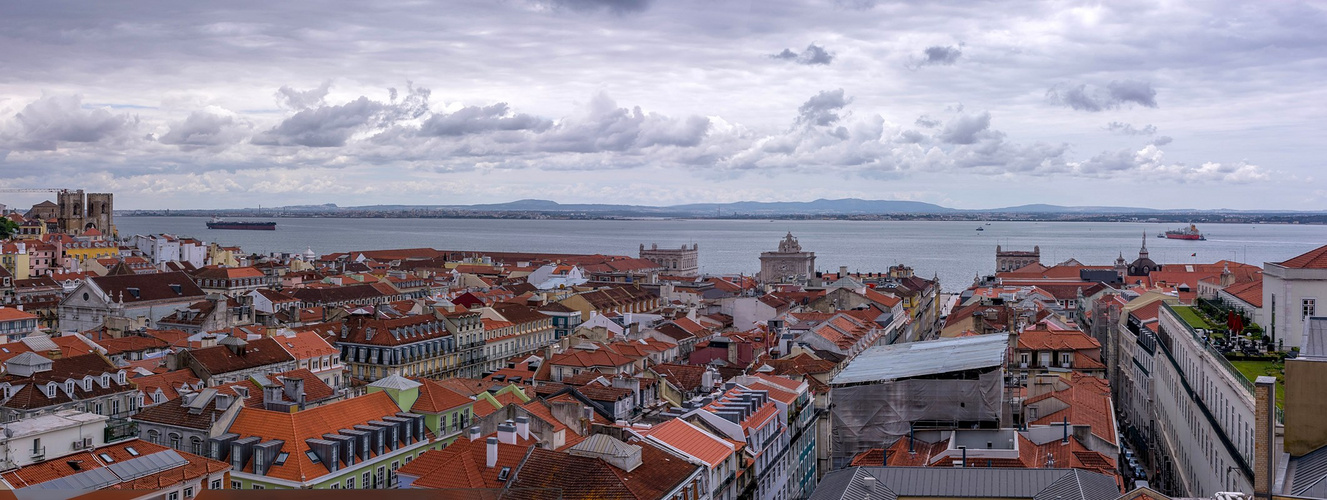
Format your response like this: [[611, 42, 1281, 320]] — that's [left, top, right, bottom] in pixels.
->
[[811, 467, 1120, 500]]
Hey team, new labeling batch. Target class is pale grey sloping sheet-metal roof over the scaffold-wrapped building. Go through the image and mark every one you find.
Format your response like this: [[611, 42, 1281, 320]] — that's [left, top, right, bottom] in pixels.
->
[[829, 333, 1009, 386]]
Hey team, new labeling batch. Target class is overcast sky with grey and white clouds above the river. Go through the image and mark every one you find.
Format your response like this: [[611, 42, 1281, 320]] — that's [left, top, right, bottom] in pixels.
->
[[0, 0, 1327, 210]]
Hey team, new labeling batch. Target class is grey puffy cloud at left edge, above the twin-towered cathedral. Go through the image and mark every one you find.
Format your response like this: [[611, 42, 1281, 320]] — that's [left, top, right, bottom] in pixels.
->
[[0, 95, 138, 151]]
